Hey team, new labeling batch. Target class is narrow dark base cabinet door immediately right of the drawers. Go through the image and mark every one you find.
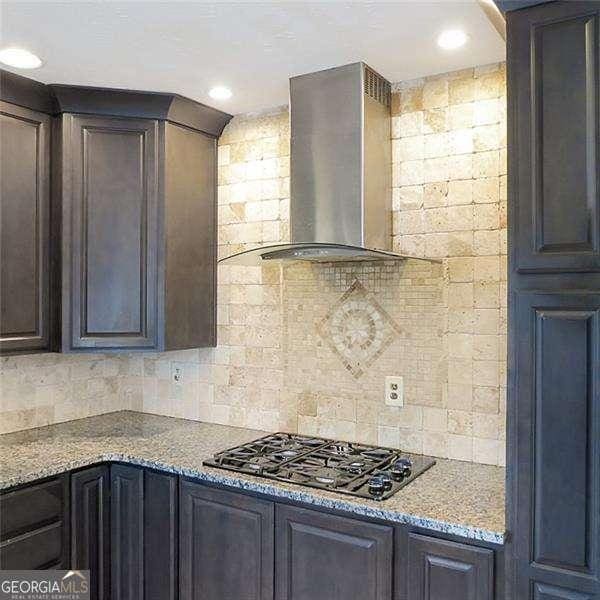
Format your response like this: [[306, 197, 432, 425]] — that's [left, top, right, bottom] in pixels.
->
[[71, 466, 110, 600]]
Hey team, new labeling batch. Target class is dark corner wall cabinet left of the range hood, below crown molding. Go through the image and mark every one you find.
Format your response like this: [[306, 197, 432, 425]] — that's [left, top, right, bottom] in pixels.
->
[[62, 115, 217, 351]]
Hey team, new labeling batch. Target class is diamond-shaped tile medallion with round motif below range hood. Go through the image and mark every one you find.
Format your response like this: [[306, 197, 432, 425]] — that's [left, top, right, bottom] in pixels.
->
[[317, 280, 401, 379]]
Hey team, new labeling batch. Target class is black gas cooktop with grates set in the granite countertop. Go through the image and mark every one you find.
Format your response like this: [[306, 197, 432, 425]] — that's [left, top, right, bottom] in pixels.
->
[[204, 433, 435, 500]]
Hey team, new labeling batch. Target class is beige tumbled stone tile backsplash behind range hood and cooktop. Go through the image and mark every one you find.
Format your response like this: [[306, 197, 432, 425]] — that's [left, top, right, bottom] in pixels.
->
[[0, 64, 506, 464]]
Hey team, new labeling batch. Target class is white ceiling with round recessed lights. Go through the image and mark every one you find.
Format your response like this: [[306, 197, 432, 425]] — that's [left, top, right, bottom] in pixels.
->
[[0, 0, 505, 114]]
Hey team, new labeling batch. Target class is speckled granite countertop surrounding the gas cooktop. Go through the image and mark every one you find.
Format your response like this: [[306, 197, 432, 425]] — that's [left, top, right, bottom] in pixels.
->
[[0, 411, 505, 544]]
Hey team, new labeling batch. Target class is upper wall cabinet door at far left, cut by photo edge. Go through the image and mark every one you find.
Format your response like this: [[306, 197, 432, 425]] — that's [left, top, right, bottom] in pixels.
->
[[0, 102, 50, 352]]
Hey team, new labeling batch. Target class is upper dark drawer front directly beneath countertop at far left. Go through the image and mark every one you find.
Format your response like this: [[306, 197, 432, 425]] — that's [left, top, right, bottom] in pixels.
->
[[0, 478, 67, 541]]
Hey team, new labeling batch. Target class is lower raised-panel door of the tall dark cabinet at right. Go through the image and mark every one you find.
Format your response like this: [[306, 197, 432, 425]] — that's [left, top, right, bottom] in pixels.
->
[[513, 291, 600, 600]]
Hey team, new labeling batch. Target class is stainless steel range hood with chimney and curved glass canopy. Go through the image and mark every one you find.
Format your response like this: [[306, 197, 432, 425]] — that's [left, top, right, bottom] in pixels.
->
[[219, 63, 422, 265]]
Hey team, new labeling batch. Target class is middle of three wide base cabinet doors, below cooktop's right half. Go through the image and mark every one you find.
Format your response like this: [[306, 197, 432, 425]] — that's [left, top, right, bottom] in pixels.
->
[[275, 505, 394, 600]]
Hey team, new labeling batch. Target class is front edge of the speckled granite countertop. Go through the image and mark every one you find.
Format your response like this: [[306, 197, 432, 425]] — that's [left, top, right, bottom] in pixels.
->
[[0, 452, 506, 545]]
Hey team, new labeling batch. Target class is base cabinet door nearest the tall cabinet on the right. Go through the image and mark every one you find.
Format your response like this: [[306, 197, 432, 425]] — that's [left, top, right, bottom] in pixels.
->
[[406, 533, 494, 600]]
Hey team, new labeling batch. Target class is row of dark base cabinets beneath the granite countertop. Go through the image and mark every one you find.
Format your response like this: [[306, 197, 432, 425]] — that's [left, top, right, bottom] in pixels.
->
[[0, 463, 502, 600]]
